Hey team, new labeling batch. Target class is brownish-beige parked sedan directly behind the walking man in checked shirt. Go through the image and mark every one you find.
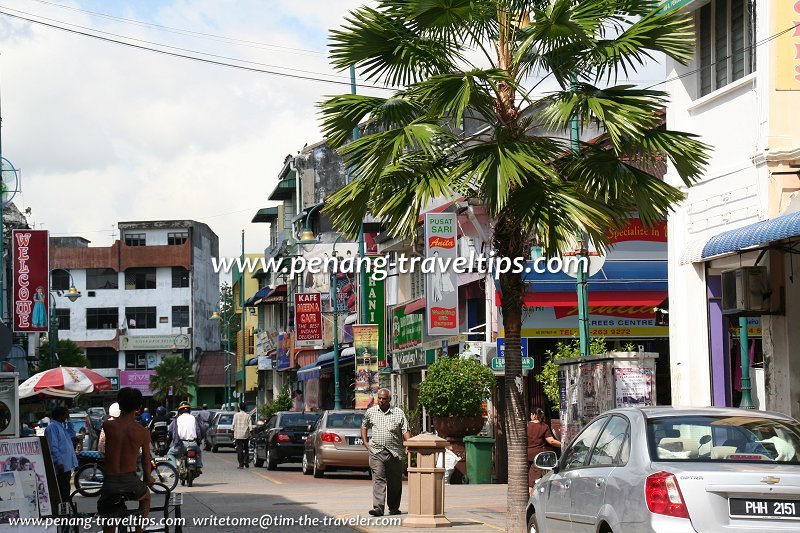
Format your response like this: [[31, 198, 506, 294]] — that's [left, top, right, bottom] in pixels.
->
[[303, 409, 370, 478]]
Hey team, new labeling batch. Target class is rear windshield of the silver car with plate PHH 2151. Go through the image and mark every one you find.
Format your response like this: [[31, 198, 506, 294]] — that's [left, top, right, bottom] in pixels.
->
[[647, 416, 800, 464]]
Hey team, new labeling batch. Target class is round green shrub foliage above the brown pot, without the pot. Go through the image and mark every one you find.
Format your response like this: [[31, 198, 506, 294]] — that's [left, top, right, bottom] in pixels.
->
[[419, 357, 494, 416]]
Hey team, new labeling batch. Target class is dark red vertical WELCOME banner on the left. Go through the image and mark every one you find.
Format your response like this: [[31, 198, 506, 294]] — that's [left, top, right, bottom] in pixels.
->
[[11, 229, 50, 332]]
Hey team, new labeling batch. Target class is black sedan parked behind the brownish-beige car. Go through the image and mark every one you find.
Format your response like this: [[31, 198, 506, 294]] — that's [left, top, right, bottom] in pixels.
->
[[253, 411, 318, 470]]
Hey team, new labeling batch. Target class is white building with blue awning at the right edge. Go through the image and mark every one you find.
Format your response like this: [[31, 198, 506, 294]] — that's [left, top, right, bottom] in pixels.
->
[[666, 0, 800, 417]]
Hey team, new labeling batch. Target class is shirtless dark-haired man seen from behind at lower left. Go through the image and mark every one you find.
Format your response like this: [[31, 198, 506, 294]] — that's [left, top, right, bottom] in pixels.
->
[[97, 387, 154, 533]]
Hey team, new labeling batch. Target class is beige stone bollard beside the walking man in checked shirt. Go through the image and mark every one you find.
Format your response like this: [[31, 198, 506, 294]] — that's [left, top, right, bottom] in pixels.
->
[[403, 434, 452, 527]]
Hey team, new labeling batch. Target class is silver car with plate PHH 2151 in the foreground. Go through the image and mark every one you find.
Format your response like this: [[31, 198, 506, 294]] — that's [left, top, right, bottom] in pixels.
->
[[527, 407, 800, 533]]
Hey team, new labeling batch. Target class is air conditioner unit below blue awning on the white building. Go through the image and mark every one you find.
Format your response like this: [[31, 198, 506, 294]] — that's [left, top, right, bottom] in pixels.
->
[[722, 266, 771, 316]]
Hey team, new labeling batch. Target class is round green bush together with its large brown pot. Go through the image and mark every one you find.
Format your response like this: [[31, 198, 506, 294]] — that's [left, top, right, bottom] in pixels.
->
[[419, 355, 495, 438]]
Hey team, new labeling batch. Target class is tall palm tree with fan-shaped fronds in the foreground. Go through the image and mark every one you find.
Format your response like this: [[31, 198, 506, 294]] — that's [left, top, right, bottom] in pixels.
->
[[320, 0, 708, 531]]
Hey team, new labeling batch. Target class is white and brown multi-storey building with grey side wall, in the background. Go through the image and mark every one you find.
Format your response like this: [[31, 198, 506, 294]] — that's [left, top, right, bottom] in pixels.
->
[[50, 220, 221, 403]]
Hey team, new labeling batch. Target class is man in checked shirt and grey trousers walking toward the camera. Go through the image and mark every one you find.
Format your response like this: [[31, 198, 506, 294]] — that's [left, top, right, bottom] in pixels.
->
[[361, 389, 411, 516]]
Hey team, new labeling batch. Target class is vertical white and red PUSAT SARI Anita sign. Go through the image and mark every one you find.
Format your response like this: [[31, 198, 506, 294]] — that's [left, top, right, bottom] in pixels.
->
[[423, 213, 458, 335]]
